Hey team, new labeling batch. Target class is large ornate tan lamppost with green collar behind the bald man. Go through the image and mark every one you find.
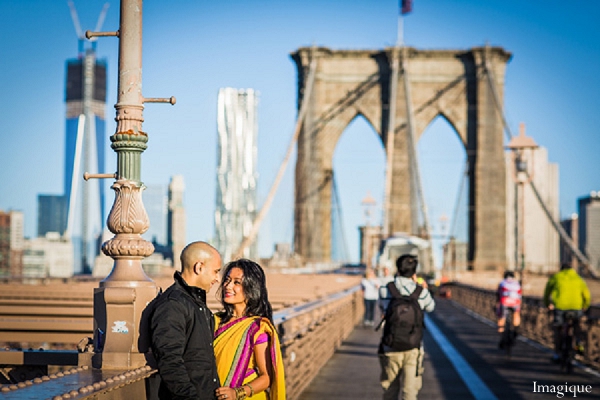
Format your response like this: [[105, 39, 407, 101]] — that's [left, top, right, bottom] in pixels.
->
[[85, 0, 175, 369]]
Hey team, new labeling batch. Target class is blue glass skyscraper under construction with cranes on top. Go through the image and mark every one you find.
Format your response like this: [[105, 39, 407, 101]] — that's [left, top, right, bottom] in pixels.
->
[[64, 1, 108, 273]]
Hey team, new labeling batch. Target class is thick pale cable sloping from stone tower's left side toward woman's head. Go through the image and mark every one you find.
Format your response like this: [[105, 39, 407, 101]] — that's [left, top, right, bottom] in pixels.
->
[[233, 51, 317, 259]]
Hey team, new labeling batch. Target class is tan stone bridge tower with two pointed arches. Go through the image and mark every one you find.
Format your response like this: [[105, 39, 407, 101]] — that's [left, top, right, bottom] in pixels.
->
[[291, 47, 511, 269]]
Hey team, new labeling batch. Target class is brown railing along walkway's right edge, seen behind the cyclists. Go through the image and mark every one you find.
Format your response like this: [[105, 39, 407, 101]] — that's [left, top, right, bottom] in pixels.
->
[[445, 283, 600, 369]]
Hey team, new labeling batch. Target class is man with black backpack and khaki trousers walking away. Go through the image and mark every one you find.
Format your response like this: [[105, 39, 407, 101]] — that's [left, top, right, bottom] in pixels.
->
[[377, 254, 435, 400]]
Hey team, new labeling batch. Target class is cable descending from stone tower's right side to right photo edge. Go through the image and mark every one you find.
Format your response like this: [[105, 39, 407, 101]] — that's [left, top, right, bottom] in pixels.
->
[[483, 49, 599, 279]]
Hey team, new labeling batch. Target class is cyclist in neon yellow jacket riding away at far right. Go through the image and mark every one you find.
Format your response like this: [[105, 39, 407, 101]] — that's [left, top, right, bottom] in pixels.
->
[[544, 264, 591, 361]]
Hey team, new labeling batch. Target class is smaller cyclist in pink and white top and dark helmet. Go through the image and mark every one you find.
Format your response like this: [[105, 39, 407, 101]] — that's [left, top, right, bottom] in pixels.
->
[[496, 271, 522, 349]]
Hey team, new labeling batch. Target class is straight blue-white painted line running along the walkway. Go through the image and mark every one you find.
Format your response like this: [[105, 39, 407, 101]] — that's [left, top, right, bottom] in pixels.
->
[[425, 315, 498, 400]]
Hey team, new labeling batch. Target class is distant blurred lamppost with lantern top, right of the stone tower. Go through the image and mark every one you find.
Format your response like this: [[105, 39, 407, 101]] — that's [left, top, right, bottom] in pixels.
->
[[507, 122, 539, 284]]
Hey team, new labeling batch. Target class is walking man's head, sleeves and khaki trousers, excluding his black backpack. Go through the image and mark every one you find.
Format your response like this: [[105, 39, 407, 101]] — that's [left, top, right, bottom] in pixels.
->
[[379, 254, 435, 400]]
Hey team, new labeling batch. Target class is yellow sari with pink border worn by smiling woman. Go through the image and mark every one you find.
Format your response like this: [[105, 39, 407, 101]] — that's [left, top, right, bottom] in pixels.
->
[[214, 315, 285, 400]]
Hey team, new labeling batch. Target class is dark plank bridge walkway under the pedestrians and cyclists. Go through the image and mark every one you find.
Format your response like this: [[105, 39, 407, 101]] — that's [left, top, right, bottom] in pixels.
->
[[300, 299, 600, 400]]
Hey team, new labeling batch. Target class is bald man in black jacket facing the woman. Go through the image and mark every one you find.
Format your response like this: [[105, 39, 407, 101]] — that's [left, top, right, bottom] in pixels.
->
[[150, 242, 221, 400]]
